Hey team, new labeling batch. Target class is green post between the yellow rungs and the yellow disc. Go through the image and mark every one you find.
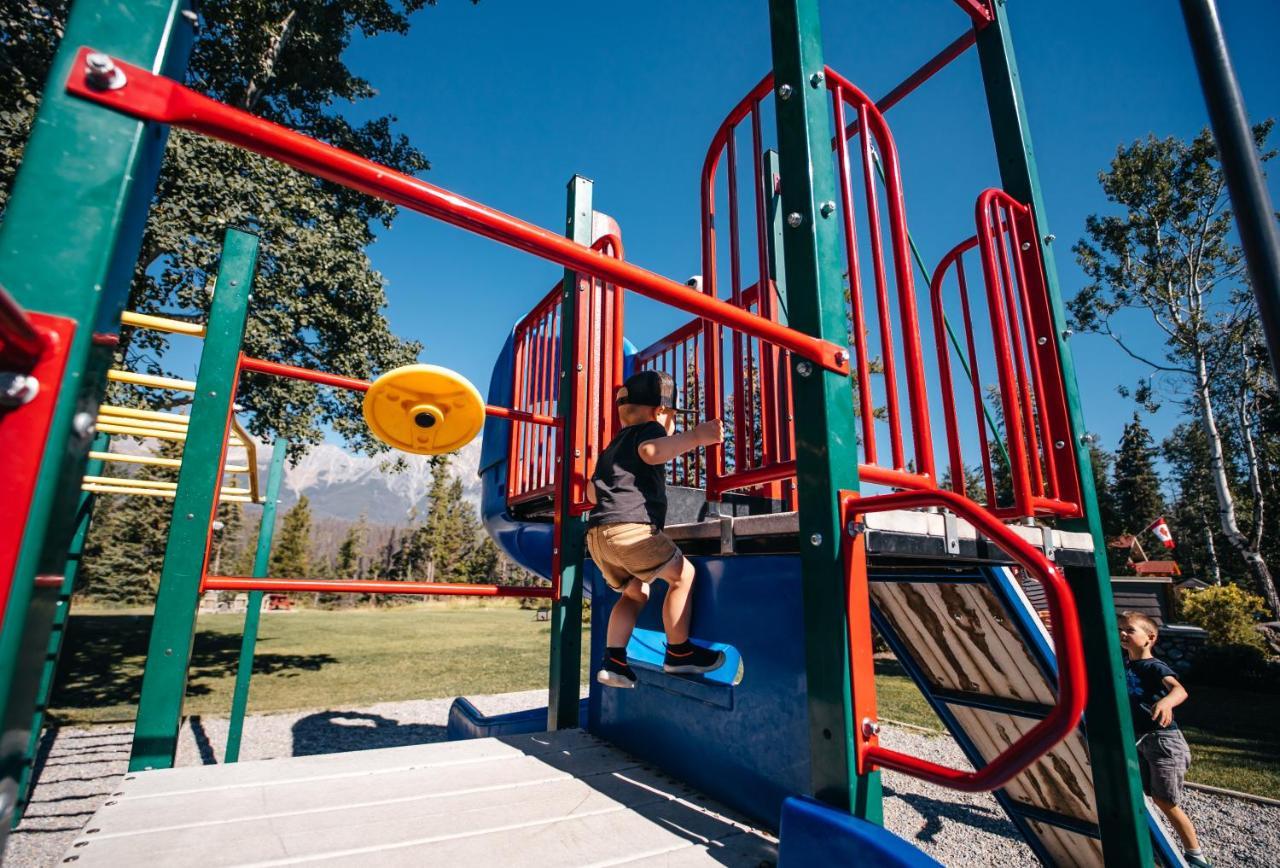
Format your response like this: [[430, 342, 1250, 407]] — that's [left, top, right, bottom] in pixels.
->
[[129, 229, 257, 772]]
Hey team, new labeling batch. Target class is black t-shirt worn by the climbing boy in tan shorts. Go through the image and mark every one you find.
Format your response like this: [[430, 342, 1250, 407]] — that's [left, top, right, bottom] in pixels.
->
[[588, 421, 667, 530]]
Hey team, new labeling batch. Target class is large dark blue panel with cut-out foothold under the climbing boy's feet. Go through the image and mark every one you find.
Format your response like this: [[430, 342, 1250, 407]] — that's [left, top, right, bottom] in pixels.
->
[[585, 556, 803, 828]]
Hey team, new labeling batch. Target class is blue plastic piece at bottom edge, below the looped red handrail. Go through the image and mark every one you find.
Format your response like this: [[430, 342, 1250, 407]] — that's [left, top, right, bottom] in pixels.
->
[[778, 796, 942, 868]]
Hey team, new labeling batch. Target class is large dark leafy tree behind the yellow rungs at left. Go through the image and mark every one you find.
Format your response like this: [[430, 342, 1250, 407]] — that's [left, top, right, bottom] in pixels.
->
[[0, 0, 481, 454]]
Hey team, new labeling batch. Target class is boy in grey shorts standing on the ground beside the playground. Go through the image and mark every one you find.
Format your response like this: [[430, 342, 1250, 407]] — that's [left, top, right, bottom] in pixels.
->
[[1120, 612, 1211, 868]]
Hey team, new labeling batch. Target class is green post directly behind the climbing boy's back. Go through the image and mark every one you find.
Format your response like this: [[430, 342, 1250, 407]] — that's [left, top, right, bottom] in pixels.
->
[[547, 175, 591, 730]]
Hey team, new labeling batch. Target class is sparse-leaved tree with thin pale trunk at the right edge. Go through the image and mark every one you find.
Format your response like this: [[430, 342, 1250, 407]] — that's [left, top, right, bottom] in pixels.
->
[[1070, 122, 1280, 613]]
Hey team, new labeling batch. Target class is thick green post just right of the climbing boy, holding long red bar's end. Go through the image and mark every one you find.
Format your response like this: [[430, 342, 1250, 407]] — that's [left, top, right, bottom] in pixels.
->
[[769, 0, 882, 823]]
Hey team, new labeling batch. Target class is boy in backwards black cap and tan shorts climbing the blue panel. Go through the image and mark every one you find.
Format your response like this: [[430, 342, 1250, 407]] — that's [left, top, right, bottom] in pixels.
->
[[586, 371, 724, 687]]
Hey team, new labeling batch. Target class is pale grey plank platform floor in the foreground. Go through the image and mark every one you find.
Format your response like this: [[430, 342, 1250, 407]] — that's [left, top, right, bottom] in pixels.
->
[[63, 730, 777, 868]]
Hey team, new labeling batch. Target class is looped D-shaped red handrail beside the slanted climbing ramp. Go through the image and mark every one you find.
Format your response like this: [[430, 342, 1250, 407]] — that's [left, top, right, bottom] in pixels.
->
[[841, 489, 1088, 792]]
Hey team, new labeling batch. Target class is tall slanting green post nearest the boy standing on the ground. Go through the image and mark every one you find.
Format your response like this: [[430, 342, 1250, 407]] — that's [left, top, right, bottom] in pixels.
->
[[978, 8, 1152, 865]]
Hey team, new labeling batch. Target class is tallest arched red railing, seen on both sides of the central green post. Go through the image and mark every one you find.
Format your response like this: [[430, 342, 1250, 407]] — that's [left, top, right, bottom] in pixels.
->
[[701, 66, 936, 497]]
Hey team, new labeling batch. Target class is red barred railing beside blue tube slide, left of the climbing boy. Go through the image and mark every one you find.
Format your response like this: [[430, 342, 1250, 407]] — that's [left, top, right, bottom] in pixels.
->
[[507, 234, 625, 512]]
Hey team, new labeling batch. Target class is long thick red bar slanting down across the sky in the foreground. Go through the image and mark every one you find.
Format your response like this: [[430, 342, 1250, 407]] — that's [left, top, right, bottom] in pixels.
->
[[67, 47, 849, 375]]
